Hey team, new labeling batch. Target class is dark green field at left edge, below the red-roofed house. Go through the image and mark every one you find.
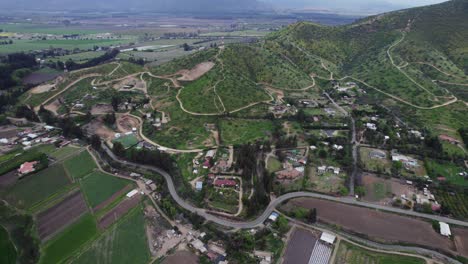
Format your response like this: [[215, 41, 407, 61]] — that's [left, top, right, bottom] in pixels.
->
[[1, 164, 70, 208]]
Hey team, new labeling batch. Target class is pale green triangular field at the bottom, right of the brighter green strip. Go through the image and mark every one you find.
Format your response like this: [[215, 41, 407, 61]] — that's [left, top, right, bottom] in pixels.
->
[[73, 206, 150, 264]]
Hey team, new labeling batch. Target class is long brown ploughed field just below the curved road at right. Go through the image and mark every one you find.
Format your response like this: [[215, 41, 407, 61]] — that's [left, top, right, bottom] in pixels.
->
[[285, 198, 455, 253]]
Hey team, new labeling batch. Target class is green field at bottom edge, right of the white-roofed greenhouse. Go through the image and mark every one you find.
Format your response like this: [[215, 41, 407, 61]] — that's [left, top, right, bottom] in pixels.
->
[[335, 241, 426, 264]]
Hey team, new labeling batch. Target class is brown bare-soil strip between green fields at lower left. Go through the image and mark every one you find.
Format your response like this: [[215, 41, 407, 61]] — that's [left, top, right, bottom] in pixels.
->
[[37, 192, 88, 241]]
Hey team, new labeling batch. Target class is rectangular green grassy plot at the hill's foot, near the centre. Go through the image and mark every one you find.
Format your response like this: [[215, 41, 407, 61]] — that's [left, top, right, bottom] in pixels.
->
[[220, 119, 273, 145]]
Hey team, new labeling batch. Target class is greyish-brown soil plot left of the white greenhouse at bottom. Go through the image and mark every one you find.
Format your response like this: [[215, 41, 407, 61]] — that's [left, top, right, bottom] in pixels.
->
[[283, 228, 318, 264]]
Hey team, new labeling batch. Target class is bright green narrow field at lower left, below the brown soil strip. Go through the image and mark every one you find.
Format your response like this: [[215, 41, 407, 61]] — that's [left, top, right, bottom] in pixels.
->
[[39, 214, 97, 264]]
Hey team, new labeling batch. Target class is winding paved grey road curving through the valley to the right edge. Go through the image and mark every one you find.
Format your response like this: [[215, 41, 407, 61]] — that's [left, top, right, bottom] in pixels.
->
[[103, 144, 468, 229]]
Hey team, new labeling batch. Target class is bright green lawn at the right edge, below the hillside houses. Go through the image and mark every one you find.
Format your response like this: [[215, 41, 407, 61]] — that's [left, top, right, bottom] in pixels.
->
[[424, 159, 468, 186]]
